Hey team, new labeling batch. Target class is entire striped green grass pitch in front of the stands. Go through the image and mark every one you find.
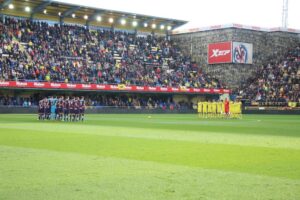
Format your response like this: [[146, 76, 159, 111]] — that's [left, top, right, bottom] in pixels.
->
[[0, 114, 300, 200]]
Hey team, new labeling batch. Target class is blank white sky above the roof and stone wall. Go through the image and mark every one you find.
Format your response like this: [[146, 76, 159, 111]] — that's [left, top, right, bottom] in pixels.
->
[[58, 0, 300, 29]]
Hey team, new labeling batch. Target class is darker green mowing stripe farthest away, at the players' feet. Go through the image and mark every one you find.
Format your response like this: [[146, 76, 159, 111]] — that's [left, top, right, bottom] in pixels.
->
[[0, 114, 300, 137]]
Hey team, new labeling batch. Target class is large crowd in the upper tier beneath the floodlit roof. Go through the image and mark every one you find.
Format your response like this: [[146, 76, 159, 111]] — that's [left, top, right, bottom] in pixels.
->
[[0, 17, 224, 88]]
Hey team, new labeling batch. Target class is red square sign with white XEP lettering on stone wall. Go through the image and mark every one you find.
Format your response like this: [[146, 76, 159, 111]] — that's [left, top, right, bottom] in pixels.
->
[[207, 42, 232, 64]]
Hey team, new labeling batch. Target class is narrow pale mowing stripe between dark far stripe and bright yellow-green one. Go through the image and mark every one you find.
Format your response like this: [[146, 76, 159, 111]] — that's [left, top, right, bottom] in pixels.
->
[[1, 123, 300, 149]]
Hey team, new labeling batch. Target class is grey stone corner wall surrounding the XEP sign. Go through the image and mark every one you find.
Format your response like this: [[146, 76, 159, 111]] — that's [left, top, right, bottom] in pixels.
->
[[171, 28, 300, 88]]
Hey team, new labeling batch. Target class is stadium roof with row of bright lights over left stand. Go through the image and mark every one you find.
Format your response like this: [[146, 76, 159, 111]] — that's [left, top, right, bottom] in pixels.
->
[[0, 0, 187, 32]]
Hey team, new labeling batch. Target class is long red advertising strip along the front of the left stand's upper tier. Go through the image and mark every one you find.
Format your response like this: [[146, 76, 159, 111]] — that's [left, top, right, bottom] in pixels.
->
[[0, 81, 230, 94]]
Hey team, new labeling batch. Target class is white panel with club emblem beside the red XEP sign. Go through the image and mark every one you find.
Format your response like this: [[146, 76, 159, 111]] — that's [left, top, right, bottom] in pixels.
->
[[232, 42, 253, 64]]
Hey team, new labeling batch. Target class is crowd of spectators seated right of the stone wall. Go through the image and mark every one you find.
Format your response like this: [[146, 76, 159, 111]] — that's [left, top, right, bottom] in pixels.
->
[[239, 47, 300, 105]]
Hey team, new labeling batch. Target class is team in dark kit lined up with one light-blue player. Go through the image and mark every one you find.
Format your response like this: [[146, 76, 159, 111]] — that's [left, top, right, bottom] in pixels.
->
[[38, 97, 85, 121]]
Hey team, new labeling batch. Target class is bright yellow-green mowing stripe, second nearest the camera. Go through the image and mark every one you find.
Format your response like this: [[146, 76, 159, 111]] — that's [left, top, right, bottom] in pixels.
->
[[0, 127, 300, 179]]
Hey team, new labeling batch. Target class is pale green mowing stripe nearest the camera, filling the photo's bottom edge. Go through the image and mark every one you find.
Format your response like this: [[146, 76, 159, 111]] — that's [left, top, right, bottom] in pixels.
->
[[0, 146, 300, 200]]
